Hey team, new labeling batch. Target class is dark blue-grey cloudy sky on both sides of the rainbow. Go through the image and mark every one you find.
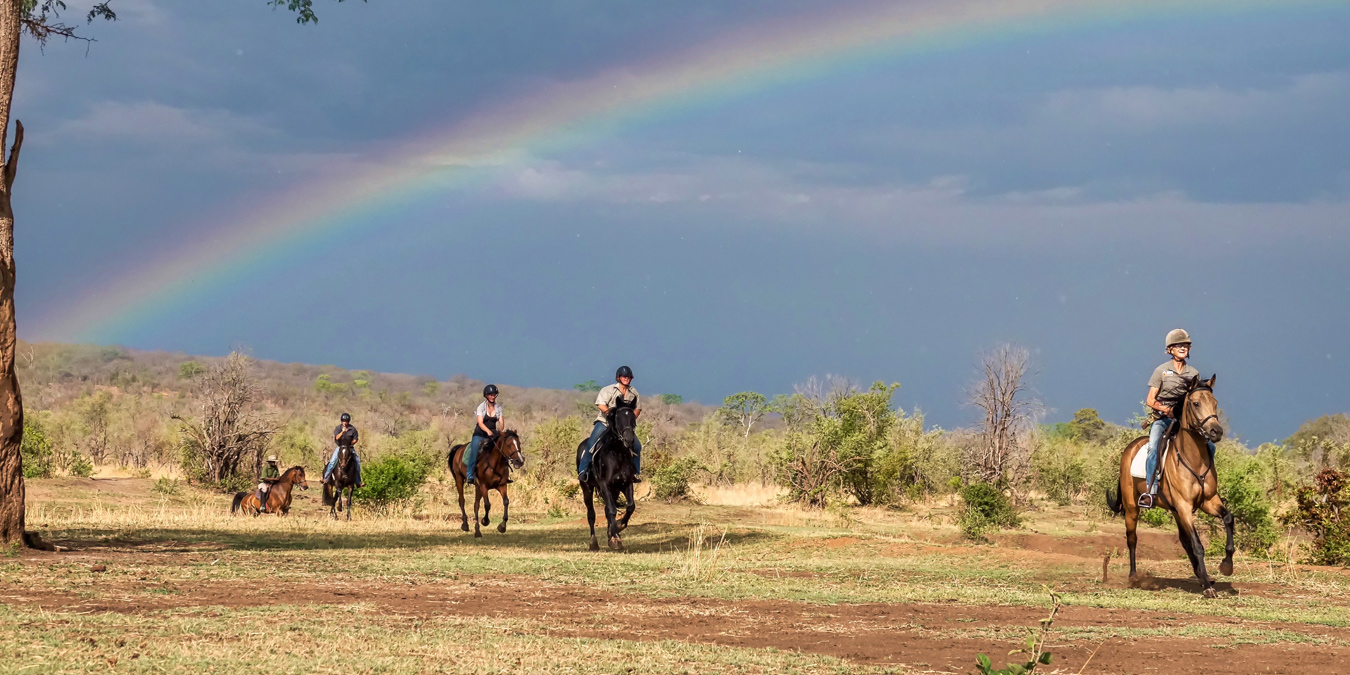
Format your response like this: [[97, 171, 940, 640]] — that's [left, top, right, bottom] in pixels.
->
[[15, 0, 1350, 441]]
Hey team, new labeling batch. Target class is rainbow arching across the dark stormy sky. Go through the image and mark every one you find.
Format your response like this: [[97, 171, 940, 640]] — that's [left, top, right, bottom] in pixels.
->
[[26, 0, 1334, 343]]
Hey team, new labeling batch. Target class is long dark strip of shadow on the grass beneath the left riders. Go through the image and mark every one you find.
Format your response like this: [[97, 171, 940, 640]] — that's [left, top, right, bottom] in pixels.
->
[[45, 522, 778, 555]]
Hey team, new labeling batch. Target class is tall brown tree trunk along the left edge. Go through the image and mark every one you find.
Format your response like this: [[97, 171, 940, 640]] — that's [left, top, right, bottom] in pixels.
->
[[0, 0, 24, 544]]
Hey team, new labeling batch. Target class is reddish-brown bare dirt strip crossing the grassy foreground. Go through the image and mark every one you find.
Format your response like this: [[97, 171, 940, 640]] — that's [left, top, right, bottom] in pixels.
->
[[0, 576, 1350, 675]]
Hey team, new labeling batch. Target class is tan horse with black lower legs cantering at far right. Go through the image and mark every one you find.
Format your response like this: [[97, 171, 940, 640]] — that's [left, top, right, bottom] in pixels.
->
[[1106, 377, 1234, 598]]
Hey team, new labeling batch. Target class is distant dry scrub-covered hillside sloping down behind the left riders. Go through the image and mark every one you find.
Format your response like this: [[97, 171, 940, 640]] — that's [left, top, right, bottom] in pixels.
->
[[18, 342, 714, 474]]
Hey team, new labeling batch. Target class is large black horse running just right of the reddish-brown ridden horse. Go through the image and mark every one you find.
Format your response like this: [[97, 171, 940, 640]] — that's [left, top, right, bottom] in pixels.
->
[[576, 406, 637, 551]]
